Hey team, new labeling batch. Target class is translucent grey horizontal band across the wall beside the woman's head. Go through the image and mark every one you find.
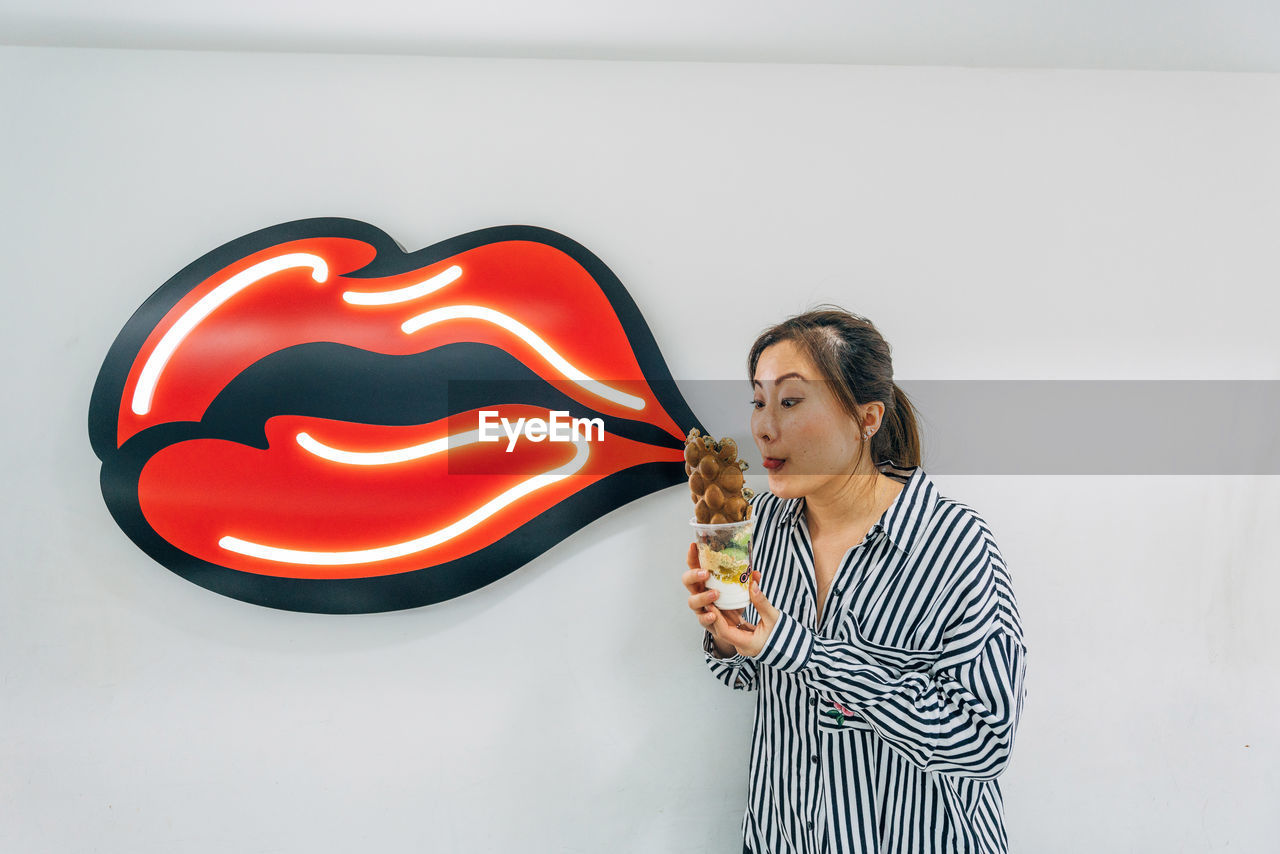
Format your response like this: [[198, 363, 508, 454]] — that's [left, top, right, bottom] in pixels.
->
[[678, 380, 1280, 475]]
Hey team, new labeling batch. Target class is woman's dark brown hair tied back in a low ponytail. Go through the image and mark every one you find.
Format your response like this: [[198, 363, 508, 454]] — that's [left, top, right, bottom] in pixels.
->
[[746, 306, 920, 467]]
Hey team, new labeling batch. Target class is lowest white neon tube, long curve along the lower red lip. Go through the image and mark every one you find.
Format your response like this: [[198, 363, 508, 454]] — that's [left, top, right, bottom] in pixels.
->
[[218, 439, 591, 566]]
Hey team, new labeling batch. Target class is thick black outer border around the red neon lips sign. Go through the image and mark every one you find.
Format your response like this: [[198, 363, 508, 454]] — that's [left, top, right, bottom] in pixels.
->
[[88, 218, 701, 613]]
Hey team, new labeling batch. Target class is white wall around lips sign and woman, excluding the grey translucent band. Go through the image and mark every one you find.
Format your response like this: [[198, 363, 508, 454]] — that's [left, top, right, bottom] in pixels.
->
[[0, 49, 1280, 854]]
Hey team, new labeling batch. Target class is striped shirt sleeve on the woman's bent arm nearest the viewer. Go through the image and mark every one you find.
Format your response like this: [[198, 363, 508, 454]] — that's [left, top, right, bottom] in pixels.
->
[[756, 540, 1027, 780]]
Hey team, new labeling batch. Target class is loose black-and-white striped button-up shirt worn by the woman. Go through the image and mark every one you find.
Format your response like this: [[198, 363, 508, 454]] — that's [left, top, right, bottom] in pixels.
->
[[703, 462, 1027, 854]]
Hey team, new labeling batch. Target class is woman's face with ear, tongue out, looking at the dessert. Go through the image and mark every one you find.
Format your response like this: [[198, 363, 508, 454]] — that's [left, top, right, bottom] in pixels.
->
[[751, 341, 879, 498]]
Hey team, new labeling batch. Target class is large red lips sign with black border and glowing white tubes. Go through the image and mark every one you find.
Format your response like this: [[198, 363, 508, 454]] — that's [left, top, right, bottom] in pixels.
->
[[88, 219, 698, 613]]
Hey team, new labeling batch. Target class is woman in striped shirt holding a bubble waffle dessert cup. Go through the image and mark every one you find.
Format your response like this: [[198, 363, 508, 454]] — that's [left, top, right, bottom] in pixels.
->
[[684, 310, 1027, 854]]
